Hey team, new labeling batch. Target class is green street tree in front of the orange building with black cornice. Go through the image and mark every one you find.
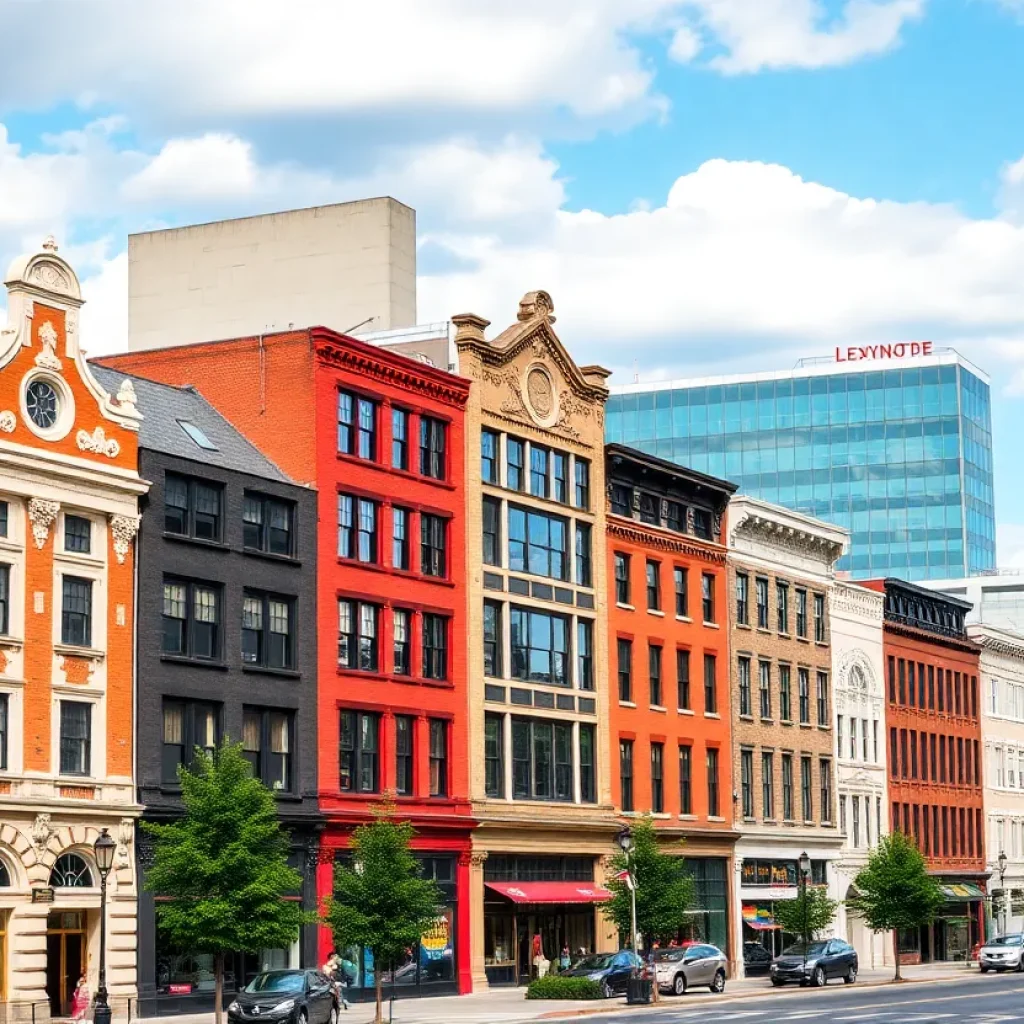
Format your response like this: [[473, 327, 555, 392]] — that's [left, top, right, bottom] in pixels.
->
[[603, 818, 694, 946]]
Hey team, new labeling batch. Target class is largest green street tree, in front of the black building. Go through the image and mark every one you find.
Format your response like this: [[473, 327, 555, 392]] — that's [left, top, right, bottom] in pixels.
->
[[141, 740, 316, 1024]]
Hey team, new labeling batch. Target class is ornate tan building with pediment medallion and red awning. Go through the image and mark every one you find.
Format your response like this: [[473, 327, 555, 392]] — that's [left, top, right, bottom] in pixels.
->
[[454, 292, 618, 988]]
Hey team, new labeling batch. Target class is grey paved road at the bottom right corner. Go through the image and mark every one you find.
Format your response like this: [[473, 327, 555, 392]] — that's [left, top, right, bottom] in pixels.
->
[[560, 974, 1024, 1024]]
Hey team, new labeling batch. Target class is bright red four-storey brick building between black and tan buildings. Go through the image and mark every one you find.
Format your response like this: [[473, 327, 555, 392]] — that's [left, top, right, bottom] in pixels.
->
[[99, 328, 473, 996]]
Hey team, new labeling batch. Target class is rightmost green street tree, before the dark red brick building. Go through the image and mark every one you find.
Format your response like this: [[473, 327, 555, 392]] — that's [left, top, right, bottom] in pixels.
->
[[847, 831, 943, 981]]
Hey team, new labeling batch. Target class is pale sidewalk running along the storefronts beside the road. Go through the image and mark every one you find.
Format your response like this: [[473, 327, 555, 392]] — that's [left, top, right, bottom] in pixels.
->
[[146, 964, 980, 1024]]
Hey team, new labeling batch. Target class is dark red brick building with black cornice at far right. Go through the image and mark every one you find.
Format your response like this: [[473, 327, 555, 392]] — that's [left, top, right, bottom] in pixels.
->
[[865, 579, 988, 962]]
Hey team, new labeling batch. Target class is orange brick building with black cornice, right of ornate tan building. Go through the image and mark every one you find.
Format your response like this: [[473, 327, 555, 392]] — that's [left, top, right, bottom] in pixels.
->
[[605, 444, 738, 963]]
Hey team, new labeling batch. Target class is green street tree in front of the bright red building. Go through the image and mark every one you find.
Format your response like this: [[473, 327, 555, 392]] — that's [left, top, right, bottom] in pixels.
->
[[327, 804, 443, 1024]]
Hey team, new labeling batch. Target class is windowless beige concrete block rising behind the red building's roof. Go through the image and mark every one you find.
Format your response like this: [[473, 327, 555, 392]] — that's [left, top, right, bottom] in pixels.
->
[[128, 197, 415, 354]]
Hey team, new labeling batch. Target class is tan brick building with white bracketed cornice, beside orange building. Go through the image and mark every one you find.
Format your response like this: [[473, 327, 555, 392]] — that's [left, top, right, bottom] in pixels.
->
[[728, 497, 847, 966]]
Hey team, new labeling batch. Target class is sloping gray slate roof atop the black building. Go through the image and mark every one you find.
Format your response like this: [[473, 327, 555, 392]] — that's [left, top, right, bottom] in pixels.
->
[[89, 362, 294, 483]]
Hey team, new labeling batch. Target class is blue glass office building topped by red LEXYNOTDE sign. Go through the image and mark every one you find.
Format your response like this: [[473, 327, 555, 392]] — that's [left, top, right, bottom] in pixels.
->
[[606, 350, 995, 580]]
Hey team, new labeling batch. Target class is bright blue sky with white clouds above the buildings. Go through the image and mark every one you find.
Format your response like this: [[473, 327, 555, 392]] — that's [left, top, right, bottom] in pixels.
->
[[0, 0, 1024, 568]]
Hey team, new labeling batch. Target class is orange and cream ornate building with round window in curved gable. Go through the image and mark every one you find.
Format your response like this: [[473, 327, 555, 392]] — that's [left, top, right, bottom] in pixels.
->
[[0, 240, 147, 1020]]
